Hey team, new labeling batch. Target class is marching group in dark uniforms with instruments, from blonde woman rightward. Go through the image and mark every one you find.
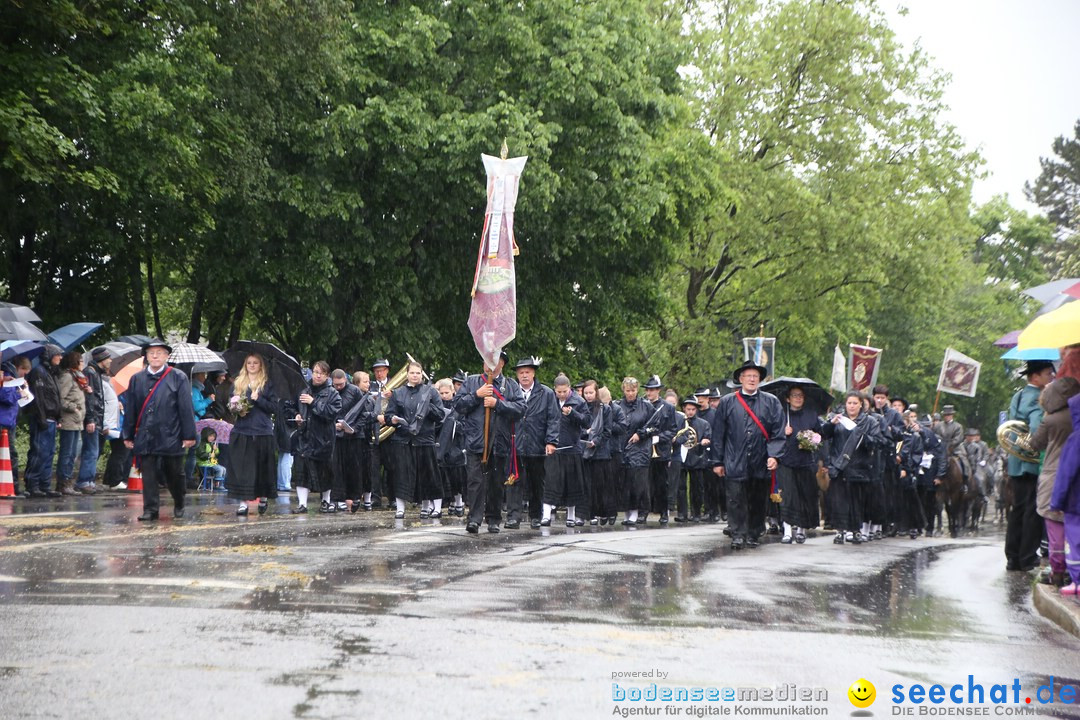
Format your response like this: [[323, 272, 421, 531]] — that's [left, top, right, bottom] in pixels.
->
[[181, 345, 985, 549]]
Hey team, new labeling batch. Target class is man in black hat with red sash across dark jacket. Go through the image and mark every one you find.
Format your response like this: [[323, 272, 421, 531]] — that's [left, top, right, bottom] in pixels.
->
[[712, 361, 784, 549]]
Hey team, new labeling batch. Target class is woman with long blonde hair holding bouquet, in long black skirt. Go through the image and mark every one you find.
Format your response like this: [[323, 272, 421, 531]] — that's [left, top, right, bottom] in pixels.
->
[[229, 353, 279, 517]]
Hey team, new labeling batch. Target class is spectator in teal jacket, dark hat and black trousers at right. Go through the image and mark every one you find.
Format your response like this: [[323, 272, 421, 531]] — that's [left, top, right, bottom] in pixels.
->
[[1005, 361, 1054, 570]]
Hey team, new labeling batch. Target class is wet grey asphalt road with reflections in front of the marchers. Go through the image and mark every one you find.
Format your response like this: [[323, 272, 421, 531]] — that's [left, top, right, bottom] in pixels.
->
[[0, 494, 1080, 719]]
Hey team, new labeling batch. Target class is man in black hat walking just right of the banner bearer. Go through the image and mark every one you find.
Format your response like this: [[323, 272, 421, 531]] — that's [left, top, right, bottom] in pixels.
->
[[503, 356, 561, 530]]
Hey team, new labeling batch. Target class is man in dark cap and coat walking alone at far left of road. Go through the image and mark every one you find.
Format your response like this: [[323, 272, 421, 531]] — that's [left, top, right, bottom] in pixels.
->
[[122, 340, 198, 521]]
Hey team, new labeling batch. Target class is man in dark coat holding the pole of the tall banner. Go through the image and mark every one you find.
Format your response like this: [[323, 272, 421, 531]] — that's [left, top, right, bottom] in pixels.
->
[[454, 352, 525, 533]]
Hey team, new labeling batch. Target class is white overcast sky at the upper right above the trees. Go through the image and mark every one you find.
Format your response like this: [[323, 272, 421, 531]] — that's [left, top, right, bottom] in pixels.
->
[[879, 0, 1080, 212]]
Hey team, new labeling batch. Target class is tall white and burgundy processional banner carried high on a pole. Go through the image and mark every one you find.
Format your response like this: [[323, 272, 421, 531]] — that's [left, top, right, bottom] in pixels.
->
[[469, 154, 528, 368]]
